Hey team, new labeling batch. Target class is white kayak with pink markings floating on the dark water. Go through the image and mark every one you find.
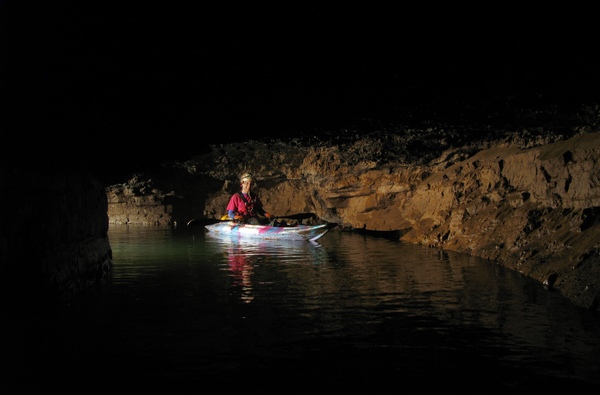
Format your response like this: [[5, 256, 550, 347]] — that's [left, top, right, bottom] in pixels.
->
[[204, 221, 329, 241]]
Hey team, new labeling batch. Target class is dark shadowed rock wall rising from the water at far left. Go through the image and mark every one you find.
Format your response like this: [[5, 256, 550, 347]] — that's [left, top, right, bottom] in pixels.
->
[[0, 168, 112, 306]]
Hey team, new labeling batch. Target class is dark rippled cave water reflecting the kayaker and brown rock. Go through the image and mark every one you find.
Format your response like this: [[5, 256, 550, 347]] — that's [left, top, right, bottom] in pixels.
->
[[3, 226, 600, 394]]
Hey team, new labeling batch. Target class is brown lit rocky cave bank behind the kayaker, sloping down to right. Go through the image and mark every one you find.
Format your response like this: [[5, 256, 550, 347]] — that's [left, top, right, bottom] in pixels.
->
[[107, 128, 600, 310]]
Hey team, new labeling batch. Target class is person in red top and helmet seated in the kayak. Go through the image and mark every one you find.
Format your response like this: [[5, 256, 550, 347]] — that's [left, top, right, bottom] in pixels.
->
[[227, 173, 275, 225]]
